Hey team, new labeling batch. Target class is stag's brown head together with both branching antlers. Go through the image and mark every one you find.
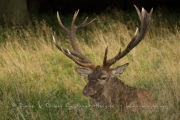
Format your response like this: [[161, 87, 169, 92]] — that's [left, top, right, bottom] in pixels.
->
[[53, 6, 153, 97]]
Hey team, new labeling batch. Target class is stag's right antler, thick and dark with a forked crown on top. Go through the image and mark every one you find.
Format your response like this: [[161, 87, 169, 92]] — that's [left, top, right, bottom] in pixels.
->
[[103, 5, 153, 68]]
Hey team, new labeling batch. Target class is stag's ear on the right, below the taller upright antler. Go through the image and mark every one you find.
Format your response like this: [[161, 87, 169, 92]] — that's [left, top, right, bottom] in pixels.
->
[[111, 63, 129, 77]]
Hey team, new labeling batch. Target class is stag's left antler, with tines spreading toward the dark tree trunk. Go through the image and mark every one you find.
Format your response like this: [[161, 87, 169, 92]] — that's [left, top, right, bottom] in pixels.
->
[[53, 10, 95, 69]]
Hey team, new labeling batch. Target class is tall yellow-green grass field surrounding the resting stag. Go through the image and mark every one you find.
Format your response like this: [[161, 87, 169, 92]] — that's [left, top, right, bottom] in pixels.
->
[[0, 10, 180, 120]]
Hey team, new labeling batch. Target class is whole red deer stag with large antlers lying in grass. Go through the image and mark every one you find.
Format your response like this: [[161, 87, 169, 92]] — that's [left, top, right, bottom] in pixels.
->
[[53, 6, 153, 111]]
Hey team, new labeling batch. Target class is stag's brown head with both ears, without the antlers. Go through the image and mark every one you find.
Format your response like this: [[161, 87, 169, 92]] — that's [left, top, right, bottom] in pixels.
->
[[76, 63, 128, 98]]
